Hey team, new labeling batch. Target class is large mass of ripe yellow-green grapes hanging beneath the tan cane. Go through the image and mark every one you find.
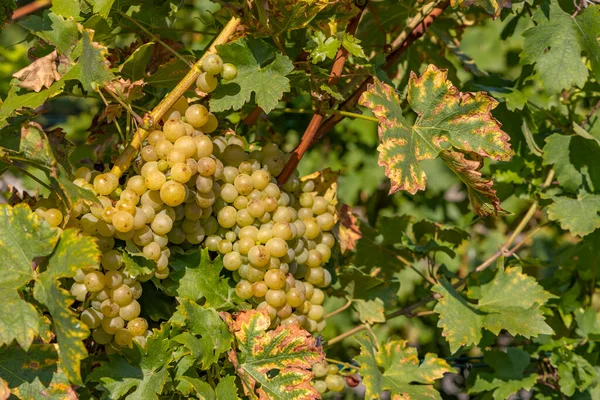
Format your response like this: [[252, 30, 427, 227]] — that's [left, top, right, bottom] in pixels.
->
[[36, 55, 335, 351]]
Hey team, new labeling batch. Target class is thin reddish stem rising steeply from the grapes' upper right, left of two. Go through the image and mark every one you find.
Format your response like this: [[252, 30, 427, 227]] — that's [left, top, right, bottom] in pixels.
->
[[277, 6, 365, 185]]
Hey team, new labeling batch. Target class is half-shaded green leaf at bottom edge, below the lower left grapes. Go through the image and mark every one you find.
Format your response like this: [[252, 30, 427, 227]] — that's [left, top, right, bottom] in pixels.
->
[[86, 328, 173, 400]]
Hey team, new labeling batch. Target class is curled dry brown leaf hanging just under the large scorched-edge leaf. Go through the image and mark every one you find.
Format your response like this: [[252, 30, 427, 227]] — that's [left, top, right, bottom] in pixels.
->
[[440, 151, 506, 217]]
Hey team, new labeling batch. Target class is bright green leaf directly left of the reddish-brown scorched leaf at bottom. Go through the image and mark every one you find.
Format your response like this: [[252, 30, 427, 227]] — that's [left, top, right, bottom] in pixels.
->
[[172, 298, 233, 370]]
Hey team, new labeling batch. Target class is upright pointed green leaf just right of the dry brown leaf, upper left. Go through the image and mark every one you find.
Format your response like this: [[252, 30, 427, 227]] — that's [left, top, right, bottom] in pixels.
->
[[68, 29, 114, 91]]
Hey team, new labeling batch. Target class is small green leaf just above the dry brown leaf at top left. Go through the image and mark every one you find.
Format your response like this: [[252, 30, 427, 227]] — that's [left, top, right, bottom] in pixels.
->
[[19, 10, 79, 61]]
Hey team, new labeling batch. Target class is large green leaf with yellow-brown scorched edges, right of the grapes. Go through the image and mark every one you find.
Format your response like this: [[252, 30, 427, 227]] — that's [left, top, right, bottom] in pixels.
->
[[359, 65, 512, 194]]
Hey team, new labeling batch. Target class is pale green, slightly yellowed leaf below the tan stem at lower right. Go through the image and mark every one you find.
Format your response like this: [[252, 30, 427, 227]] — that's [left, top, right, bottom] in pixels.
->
[[432, 267, 555, 353]]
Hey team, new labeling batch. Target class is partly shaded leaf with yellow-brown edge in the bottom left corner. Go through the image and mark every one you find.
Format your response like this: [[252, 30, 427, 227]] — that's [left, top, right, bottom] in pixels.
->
[[0, 344, 77, 400]]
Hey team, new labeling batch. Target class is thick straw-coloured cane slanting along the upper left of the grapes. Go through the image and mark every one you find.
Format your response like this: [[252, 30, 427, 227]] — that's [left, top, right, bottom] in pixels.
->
[[110, 17, 240, 177]]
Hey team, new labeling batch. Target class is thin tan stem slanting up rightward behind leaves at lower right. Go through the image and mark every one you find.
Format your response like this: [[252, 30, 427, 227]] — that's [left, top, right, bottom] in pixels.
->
[[326, 170, 554, 346]]
